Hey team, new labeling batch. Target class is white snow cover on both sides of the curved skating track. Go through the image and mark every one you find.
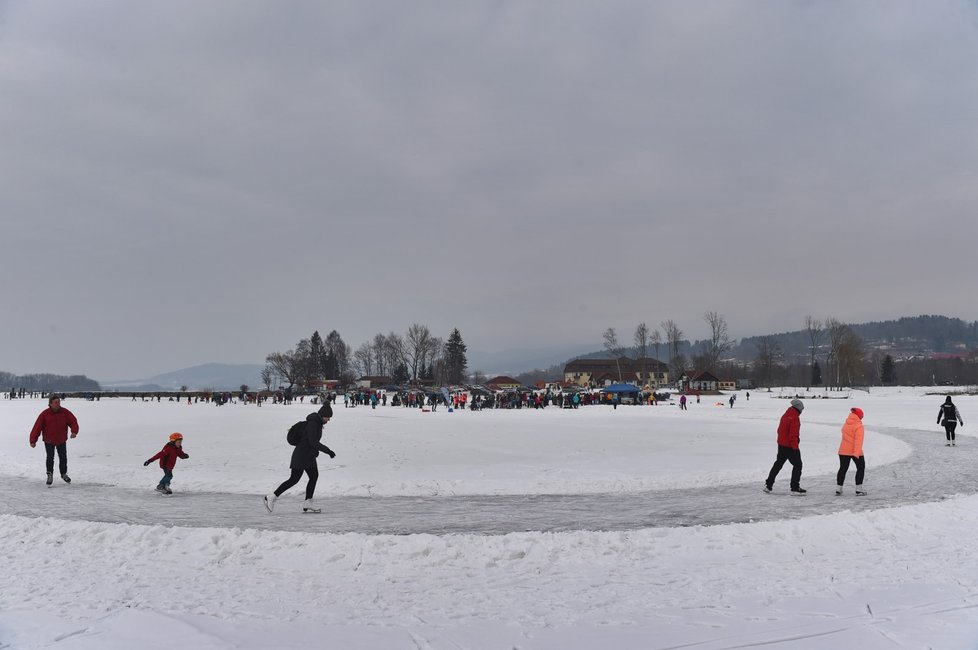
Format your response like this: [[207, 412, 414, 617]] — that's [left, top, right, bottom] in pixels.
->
[[0, 388, 978, 650]]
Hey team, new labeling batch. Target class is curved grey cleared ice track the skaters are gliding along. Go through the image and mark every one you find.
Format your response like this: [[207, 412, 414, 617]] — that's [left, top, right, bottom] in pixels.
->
[[0, 428, 964, 535]]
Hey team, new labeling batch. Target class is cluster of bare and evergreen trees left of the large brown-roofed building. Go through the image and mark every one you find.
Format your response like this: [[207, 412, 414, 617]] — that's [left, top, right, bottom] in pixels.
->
[[261, 323, 468, 390]]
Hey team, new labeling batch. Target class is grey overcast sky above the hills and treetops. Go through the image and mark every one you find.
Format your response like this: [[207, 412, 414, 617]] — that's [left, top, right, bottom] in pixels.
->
[[0, 0, 978, 380]]
